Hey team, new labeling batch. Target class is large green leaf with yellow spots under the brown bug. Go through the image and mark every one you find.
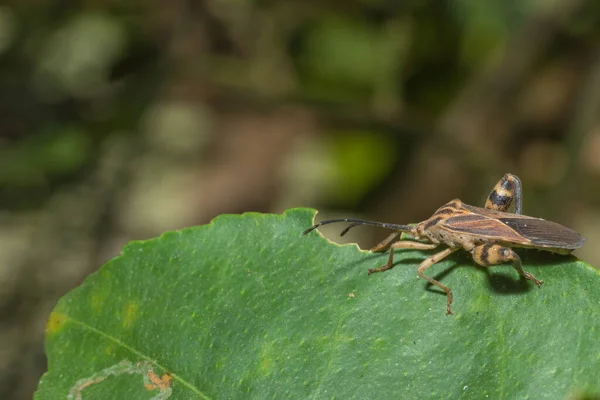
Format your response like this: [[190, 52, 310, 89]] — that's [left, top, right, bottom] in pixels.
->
[[35, 209, 600, 400]]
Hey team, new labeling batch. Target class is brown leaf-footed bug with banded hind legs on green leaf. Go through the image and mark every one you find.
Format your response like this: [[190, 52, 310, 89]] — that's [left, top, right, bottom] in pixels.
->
[[302, 174, 585, 315]]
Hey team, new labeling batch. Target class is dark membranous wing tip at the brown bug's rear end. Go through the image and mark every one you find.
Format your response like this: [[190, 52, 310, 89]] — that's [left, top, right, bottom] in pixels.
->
[[498, 217, 585, 249]]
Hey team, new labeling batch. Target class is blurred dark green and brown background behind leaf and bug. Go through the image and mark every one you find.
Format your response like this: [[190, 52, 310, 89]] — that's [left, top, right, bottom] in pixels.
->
[[0, 0, 600, 399]]
